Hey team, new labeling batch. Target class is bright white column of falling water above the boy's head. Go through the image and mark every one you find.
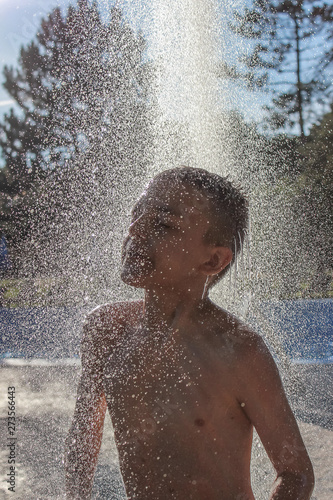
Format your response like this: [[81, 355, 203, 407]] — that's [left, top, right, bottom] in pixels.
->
[[150, 0, 221, 170]]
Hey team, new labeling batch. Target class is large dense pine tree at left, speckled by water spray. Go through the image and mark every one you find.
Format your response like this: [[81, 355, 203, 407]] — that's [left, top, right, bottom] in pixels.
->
[[0, 0, 149, 288]]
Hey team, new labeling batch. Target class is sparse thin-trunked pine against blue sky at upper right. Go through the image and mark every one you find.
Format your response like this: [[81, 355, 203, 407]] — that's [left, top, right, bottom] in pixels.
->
[[229, 0, 333, 139]]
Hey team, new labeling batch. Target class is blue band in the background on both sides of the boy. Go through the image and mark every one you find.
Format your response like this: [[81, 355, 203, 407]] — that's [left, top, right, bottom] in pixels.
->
[[0, 299, 333, 364]]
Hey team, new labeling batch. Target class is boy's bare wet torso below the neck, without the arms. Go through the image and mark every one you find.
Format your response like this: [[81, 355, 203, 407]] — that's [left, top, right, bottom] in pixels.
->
[[98, 303, 253, 500]]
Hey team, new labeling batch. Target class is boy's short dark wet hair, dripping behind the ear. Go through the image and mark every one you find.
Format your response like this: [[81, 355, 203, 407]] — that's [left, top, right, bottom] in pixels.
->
[[152, 167, 249, 288]]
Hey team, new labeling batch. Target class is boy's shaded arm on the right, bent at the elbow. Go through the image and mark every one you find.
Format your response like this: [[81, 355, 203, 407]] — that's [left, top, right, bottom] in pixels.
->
[[239, 335, 314, 500]]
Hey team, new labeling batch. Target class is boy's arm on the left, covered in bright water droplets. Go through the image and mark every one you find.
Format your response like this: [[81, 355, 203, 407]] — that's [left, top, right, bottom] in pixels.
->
[[65, 312, 106, 500]]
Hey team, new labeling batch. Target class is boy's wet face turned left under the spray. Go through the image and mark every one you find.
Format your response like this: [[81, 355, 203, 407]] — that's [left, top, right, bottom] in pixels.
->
[[121, 178, 211, 293]]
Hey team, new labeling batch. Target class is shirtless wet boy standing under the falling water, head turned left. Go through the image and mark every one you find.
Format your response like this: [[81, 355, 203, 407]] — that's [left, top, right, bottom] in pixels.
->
[[65, 167, 314, 500]]
